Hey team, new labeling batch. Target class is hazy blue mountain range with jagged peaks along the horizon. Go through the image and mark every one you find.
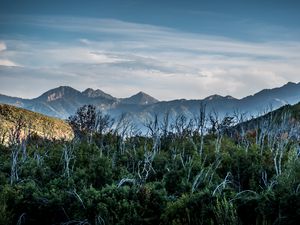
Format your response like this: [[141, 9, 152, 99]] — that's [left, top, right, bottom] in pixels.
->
[[0, 82, 300, 126]]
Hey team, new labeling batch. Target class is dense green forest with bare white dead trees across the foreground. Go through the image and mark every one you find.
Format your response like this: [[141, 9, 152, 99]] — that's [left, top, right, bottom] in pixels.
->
[[0, 105, 300, 225]]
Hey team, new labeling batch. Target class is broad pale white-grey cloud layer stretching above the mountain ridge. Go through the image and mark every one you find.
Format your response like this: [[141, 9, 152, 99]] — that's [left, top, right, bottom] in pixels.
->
[[0, 17, 300, 100]]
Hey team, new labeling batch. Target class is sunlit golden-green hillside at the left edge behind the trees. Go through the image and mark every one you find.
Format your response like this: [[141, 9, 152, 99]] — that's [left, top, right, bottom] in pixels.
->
[[0, 104, 73, 140]]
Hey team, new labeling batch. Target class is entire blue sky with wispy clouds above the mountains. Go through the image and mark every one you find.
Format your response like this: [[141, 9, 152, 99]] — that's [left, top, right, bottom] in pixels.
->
[[0, 0, 300, 100]]
